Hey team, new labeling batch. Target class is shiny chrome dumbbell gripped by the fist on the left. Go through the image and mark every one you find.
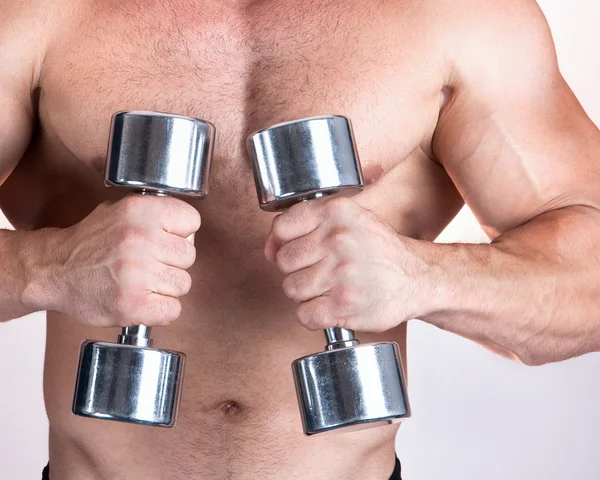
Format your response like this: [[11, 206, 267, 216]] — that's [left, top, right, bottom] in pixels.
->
[[72, 112, 215, 427]]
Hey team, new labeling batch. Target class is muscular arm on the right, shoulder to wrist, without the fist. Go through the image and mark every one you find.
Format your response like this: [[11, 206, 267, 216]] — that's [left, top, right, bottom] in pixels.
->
[[428, 0, 600, 364]]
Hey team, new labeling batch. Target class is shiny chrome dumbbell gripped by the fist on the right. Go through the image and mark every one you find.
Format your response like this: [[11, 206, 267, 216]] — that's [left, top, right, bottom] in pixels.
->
[[247, 116, 410, 435]]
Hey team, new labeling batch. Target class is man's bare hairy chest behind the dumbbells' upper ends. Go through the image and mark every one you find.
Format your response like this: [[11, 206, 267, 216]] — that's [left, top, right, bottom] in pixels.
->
[[4, 0, 448, 237]]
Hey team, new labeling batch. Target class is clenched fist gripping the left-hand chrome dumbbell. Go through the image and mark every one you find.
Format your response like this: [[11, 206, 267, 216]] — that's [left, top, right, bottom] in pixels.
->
[[48, 195, 200, 327]]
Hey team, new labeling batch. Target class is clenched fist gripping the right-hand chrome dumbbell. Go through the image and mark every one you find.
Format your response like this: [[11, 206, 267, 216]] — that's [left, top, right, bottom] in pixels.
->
[[265, 198, 432, 332]]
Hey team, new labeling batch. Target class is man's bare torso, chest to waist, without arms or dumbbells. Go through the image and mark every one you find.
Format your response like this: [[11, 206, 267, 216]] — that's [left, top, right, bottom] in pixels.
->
[[0, 0, 461, 480]]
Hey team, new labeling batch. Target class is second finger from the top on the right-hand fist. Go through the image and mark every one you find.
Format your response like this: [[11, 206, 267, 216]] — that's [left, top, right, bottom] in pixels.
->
[[275, 228, 326, 275]]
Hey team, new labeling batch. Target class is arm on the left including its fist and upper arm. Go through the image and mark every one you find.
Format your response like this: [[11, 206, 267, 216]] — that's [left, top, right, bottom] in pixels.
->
[[0, 0, 206, 327]]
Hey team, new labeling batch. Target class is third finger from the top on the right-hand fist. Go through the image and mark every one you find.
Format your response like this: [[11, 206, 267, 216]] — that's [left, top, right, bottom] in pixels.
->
[[283, 260, 336, 303]]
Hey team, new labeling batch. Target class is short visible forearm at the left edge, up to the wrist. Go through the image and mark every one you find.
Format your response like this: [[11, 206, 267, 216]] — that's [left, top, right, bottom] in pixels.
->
[[0, 229, 58, 322]]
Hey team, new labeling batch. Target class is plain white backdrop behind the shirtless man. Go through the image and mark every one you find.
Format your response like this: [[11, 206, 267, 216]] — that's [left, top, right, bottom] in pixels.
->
[[0, 0, 600, 480]]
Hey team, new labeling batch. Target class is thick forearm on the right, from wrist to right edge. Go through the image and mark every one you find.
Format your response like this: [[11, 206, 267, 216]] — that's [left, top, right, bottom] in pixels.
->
[[422, 207, 600, 364]]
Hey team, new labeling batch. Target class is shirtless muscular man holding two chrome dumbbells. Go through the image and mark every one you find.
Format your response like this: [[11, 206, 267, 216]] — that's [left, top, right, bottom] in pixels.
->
[[0, 0, 600, 480]]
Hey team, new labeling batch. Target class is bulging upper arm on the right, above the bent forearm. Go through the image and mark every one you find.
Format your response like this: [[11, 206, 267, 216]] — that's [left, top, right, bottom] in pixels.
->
[[434, 0, 600, 238]]
